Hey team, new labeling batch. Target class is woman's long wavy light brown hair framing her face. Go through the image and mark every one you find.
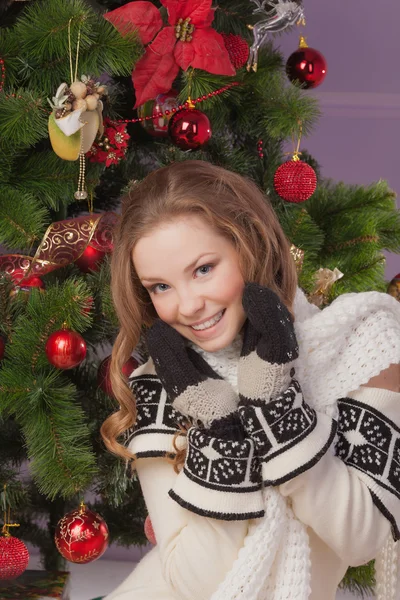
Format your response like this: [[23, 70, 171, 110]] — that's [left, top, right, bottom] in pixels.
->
[[101, 160, 297, 468]]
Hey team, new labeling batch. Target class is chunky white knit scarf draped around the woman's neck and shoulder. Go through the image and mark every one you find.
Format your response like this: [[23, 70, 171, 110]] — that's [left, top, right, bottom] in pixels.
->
[[191, 289, 400, 600]]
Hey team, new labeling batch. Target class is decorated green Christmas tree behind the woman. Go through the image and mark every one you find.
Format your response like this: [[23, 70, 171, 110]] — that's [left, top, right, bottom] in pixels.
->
[[0, 0, 400, 590]]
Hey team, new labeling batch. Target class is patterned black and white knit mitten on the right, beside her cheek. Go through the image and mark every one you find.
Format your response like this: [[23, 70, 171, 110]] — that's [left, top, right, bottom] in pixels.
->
[[238, 283, 336, 485]]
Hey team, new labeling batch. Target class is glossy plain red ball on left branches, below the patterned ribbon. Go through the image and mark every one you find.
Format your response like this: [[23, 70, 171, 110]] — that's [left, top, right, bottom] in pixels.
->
[[45, 329, 86, 369]]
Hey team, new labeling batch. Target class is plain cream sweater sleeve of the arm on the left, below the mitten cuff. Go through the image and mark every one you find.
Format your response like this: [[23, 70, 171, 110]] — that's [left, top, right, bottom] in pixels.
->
[[137, 458, 248, 600]]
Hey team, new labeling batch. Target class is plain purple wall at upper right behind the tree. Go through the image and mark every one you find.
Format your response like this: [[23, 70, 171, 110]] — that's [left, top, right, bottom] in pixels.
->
[[275, 0, 400, 280]]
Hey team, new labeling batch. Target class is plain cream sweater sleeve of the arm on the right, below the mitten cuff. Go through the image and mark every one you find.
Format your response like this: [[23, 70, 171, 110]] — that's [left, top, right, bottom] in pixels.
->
[[279, 388, 400, 566]]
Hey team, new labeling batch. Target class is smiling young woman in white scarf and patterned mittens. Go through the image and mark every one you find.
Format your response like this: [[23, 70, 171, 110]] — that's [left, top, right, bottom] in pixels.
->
[[102, 161, 400, 600]]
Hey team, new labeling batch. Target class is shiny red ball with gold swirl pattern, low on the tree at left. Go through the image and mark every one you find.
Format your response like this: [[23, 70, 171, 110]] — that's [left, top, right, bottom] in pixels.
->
[[54, 502, 109, 564]]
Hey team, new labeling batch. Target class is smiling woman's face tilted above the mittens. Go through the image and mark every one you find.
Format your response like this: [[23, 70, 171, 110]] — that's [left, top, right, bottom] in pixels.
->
[[132, 215, 246, 352]]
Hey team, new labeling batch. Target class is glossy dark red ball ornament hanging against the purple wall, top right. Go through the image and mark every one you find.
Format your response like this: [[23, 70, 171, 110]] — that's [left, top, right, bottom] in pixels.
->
[[286, 37, 328, 89]]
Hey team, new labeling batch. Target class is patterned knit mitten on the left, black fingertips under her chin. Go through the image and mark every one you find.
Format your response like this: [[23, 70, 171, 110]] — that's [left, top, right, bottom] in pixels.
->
[[147, 320, 264, 520]]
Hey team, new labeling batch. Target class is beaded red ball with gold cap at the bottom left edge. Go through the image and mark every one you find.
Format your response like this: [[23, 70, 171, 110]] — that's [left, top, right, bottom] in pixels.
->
[[0, 484, 29, 580]]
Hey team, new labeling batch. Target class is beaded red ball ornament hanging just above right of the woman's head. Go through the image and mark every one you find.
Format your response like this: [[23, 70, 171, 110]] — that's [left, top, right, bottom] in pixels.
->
[[274, 159, 317, 203]]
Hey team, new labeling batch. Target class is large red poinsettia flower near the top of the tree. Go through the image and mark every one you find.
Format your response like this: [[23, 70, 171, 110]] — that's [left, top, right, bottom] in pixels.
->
[[105, 0, 235, 108]]
